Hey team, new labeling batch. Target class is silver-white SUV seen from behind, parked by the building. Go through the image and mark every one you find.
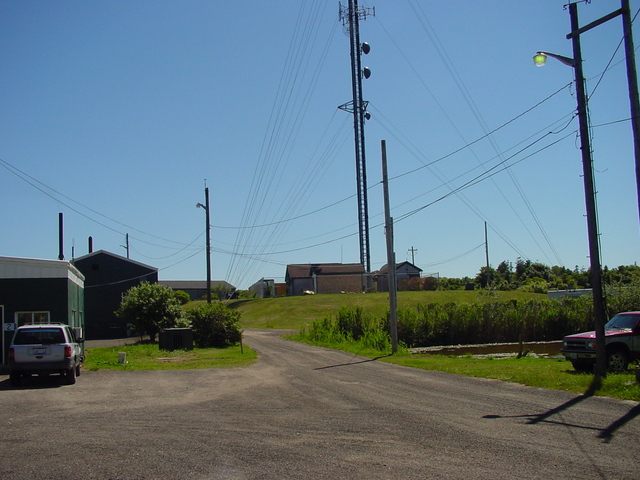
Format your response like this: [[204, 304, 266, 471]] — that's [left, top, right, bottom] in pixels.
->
[[9, 324, 84, 387]]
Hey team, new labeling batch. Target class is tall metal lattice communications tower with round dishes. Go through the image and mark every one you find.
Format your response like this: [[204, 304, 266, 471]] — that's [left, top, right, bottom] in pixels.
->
[[338, 0, 375, 273]]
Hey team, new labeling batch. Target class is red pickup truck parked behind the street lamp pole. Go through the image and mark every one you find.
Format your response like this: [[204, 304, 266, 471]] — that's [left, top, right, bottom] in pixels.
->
[[562, 312, 640, 372]]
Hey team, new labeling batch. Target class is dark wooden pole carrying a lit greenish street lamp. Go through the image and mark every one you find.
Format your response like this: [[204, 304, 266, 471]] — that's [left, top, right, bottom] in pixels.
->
[[533, 3, 607, 377]]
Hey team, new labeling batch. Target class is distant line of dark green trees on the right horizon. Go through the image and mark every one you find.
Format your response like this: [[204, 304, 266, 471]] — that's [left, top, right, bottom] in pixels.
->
[[439, 258, 640, 293]]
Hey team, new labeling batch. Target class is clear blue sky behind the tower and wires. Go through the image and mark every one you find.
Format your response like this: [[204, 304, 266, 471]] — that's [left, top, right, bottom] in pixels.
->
[[0, 0, 640, 288]]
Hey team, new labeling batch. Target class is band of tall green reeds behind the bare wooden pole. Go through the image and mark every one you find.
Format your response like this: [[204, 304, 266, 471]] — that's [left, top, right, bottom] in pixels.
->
[[300, 297, 608, 351]]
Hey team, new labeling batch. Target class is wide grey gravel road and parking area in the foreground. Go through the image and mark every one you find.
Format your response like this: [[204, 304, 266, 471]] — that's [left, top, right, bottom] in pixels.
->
[[0, 330, 640, 480]]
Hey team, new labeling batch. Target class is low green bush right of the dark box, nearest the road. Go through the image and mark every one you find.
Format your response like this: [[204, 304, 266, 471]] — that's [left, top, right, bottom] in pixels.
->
[[187, 302, 242, 348]]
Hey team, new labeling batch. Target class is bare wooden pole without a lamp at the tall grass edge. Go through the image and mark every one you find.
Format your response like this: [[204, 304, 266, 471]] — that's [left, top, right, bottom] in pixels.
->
[[381, 140, 398, 353]]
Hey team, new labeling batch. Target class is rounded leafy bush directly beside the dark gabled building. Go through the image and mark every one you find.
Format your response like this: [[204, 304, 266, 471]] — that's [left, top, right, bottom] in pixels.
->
[[115, 282, 182, 341]]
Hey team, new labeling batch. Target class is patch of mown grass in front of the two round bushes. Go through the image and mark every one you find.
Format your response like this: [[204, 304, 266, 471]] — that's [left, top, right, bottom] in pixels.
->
[[84, 343, 257, 372]]
